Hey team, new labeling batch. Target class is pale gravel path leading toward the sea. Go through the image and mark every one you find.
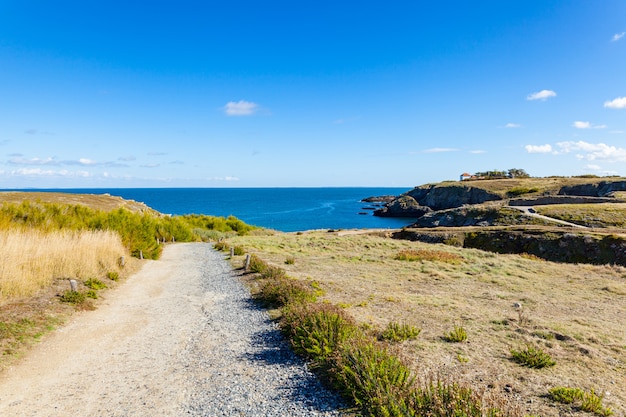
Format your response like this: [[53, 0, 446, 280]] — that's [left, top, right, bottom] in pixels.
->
[[0, 243, 342, 416]]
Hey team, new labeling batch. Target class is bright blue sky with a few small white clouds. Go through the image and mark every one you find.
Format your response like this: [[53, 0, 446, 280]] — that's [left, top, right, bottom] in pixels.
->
[[0, 0, 626, 188]]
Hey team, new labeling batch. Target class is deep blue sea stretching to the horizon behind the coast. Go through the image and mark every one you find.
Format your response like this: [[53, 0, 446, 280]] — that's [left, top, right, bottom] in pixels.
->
[[12, 187, 413, 232]]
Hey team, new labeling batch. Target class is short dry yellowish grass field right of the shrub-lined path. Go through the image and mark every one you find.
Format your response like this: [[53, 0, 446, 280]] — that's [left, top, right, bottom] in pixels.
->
[[229, 232, 626, 416]]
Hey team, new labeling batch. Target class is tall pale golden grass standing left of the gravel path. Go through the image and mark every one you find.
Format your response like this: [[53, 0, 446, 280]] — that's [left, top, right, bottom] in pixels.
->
[[0, 230, 126, 304]]
